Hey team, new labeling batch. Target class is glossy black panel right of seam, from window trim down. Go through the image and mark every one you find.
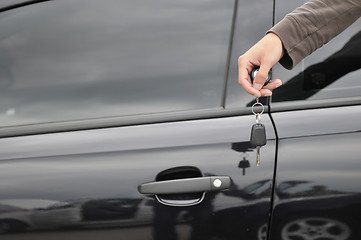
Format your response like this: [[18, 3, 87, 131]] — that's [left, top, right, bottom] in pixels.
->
[[271, 106, 361, 240]]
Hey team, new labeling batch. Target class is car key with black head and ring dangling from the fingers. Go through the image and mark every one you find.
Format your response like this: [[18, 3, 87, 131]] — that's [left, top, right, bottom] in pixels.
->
[[250, 98, 267, 166]]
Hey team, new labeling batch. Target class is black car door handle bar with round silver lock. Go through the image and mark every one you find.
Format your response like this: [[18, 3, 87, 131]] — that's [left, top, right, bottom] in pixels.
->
[[138, 176, 232, 195]]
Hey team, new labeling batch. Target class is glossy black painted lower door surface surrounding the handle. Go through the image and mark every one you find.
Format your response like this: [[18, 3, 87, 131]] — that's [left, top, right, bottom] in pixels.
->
[[0, 116, 275, 239]]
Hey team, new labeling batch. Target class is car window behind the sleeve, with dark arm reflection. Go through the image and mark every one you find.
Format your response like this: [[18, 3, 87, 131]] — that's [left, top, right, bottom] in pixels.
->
[[272, 0, 361, 105]]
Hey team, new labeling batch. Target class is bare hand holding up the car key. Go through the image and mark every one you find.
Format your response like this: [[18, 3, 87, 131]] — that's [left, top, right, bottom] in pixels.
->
[[238, 32, 284, 97]]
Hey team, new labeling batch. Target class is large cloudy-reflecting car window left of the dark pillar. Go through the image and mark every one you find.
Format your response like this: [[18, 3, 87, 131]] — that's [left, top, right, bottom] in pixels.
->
[[0, 0, 234, 127]]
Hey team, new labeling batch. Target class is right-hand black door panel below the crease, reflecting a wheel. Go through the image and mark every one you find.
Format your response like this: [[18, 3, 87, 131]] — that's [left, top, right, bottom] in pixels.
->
[[271, 131, 361, 240]]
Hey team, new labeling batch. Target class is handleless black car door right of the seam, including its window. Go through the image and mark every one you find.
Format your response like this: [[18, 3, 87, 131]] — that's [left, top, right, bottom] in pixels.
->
[[270, 0, 361, 240]]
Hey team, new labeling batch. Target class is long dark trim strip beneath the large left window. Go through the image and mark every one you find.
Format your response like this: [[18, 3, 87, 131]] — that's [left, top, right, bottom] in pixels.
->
[[0, 105, 269, 138]]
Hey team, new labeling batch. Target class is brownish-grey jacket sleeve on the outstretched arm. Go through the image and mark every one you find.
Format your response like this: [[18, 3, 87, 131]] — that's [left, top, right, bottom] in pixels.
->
[[268, 0, 361, 69]]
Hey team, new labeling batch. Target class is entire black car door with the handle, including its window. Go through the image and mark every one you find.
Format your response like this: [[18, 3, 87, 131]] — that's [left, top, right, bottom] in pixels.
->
[[0, 0, 276, 240]]
